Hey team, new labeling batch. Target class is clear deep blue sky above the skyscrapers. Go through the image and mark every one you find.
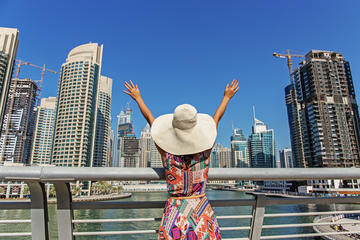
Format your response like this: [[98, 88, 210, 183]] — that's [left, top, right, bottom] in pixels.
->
[[0, 0, 360, 149]]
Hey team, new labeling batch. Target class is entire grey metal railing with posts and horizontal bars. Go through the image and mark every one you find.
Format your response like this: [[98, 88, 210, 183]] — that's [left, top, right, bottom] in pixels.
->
[[0, 167, 360, 240]]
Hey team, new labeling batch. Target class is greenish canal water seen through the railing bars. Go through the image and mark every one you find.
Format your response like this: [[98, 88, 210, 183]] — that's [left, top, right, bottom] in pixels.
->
[[0, 190, 360, 240]]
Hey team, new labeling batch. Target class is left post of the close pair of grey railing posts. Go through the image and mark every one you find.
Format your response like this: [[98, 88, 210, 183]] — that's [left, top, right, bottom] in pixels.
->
[[26, 181, 50, 240]]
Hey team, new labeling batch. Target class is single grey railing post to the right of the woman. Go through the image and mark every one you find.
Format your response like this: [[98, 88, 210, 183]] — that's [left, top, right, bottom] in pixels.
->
[[249, 194, 266, 240]]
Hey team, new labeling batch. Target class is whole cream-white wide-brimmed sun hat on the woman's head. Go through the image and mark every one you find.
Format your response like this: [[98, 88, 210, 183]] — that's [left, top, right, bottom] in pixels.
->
[[151, 104, 217, 155]]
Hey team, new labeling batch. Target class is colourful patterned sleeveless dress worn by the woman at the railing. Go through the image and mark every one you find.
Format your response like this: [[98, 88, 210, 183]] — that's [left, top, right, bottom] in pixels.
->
[[158, 152, 221, 240]]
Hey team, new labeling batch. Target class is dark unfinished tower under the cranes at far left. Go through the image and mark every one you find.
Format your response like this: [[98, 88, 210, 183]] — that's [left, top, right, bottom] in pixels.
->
[[0, 78, 37, 165]]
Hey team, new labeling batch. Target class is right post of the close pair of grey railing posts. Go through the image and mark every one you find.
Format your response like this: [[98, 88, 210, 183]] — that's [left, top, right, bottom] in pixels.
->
[[53, 182, 75, 240]]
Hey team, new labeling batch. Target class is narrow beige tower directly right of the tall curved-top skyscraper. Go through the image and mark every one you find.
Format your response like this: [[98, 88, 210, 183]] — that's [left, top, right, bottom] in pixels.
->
[[93, 76, 112, 167]]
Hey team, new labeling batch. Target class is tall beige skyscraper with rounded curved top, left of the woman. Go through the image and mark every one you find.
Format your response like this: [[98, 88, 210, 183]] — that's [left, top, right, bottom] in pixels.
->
[[52, 43, 103, 167]]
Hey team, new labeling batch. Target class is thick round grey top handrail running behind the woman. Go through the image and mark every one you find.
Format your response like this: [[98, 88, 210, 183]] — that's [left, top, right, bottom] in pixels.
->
[[0, 166, 360, 182]]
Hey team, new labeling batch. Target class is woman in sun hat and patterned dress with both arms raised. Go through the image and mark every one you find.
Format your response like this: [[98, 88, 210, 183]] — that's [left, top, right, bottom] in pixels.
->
[[124, 80, 239, 240]]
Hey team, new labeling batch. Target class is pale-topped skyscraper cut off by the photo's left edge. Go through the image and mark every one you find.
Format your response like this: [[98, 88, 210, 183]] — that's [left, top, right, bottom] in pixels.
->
[[0, 27, 19, 129]]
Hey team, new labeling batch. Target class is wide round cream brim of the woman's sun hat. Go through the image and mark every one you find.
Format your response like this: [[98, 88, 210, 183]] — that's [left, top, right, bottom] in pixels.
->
[[151, 113, 217, 155]]
